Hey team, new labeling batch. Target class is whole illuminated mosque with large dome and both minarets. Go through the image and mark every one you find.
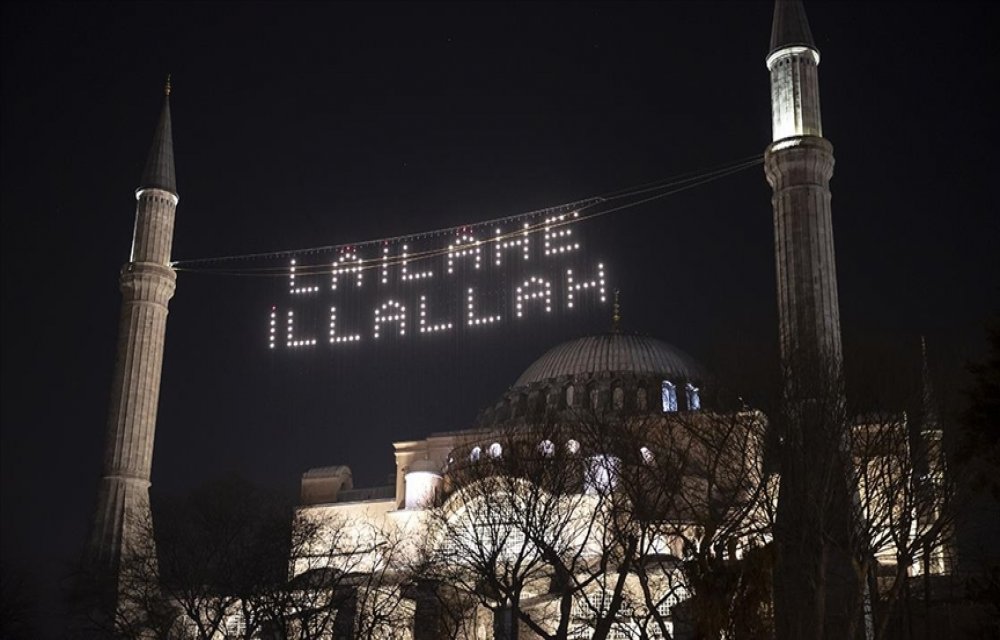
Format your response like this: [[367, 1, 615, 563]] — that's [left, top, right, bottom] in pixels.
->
[[91, 0, 949, 640]]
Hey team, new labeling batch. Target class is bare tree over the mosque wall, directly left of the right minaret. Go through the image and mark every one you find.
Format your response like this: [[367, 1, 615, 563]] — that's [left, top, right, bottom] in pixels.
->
[[548, 404, 776, 638]]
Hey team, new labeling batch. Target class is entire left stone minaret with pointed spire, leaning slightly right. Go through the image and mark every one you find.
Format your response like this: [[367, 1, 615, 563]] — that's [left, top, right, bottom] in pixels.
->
[[90, 82, 178, 575]]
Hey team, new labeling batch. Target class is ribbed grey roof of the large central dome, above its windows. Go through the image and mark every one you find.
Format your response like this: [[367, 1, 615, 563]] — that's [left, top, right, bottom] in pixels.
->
[[514, 333, 705, 387]]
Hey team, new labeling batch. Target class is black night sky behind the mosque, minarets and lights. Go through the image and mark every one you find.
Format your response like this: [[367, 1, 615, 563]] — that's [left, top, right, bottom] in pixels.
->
[[0, 2, 1000, 624]]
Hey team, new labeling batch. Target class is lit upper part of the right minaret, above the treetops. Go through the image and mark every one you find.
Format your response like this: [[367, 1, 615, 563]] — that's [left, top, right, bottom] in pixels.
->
[[764, 0, 841, 399]]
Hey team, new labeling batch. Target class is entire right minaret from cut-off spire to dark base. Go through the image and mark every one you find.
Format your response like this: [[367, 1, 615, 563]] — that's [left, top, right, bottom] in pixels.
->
[[764, 0, 861, 640]]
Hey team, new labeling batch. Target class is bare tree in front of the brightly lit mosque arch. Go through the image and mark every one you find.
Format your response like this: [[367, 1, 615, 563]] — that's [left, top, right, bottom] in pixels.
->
[[428, 425, 632, 638]]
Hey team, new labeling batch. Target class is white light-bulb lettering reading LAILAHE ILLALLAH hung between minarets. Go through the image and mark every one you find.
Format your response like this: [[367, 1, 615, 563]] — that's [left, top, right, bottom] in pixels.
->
[[268, 212, 607, 349]]
